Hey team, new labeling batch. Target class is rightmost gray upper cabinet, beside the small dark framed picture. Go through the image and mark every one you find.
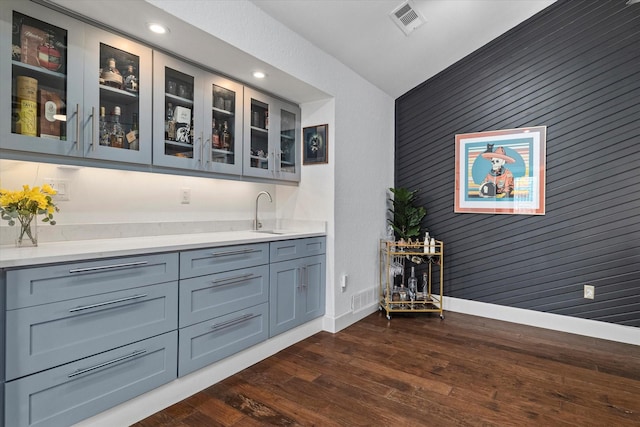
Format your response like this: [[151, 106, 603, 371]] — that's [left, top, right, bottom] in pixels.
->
[[243, 87, 301, 181]]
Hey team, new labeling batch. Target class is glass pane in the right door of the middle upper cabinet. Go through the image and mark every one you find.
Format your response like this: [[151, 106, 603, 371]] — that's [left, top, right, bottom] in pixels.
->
[[211, 85, 237, 164]]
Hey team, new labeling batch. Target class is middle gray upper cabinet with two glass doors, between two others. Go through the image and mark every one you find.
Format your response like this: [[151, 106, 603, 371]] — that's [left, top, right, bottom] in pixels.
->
[[153, 51, 243, 175]]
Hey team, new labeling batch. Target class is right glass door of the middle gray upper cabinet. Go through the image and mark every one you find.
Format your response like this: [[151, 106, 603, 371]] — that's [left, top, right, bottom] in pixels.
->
[[207, 76, 243, 175]]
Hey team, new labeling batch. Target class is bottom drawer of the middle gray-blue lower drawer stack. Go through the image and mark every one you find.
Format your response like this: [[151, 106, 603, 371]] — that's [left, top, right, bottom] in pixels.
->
[[178, 303, 269, 376]]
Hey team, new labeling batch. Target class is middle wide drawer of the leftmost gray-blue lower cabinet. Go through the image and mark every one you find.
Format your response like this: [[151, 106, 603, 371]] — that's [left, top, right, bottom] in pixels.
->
[[5, 282, 178, 380]]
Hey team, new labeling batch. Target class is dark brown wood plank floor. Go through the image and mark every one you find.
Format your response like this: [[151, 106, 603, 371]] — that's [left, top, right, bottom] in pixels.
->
[[135, 313, 640, 427]]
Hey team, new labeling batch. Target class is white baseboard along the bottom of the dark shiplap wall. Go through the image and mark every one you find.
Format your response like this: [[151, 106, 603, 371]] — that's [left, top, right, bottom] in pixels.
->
[[444, 296, 640, 346]]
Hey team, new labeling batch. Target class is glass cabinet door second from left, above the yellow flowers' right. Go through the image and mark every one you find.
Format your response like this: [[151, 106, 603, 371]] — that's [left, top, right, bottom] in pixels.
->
[[84, 30, 152, 163]]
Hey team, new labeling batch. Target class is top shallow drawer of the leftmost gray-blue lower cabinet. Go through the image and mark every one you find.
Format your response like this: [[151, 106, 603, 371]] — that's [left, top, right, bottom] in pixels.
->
[[7, 253, 178, 310]]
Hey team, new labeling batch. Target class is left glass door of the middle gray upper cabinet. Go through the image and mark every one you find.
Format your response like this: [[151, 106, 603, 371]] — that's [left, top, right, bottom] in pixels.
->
[[153, 52, 204, 170]]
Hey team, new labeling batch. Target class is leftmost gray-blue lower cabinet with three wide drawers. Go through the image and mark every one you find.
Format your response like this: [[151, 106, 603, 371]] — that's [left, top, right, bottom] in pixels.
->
[[2, 253, 179, 427]]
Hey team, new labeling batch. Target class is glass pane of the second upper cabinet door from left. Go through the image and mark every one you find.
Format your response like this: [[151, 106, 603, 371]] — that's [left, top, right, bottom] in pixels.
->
[[98, 43, 140, 151]]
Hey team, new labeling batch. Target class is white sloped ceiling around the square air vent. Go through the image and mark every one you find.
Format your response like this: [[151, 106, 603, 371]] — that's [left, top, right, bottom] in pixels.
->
[[253, 0, 555, 98]]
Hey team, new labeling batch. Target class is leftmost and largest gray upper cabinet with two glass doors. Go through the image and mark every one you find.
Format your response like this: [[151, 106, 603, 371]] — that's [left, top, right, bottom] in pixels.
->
[[0, 1, 152, 164]]
